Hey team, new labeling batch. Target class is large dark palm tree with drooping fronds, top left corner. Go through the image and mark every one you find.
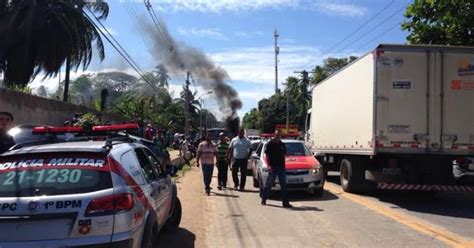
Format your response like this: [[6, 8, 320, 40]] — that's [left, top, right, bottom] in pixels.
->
[[0, 0, 109, 101]]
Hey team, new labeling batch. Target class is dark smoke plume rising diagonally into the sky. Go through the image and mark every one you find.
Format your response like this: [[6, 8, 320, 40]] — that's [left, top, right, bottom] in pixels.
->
[[146, 17, 242, 128]]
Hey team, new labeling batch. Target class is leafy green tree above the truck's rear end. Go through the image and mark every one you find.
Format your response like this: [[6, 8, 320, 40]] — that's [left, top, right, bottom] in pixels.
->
[[402, 0, 474, 46]]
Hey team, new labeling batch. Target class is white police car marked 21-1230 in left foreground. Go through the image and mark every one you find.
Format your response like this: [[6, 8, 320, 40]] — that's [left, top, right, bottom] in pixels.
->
[[0, 127, 181, 248]]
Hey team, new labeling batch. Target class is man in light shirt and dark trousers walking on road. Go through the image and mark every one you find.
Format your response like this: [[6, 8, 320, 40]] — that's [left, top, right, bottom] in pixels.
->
[[227, 128, 251, 191]]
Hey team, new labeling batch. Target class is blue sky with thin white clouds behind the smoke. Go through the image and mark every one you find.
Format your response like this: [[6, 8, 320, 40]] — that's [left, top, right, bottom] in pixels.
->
[[31, 0, 410, 118]]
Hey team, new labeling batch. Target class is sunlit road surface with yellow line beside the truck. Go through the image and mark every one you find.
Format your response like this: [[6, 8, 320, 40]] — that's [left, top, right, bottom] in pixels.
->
[[160, 168, 474, 247]]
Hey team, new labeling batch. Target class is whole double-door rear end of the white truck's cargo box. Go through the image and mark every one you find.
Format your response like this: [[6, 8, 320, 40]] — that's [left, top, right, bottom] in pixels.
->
[[376, 49, 474, 155]]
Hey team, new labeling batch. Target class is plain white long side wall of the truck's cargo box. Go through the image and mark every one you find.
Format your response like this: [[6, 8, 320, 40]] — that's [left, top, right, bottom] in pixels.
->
[[309, 53, 375, 155]]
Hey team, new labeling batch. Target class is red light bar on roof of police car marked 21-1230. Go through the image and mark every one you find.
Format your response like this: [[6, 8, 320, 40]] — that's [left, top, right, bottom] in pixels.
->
[[33, 124, 138, 134]]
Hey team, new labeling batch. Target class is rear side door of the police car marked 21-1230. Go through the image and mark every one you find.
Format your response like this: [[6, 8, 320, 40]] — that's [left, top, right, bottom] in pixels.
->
[[135, 148, 162, 219]]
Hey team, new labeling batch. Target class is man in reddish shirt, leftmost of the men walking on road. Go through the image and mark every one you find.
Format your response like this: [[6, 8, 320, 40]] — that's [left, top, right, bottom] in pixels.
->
[[196, 135, 217, 195]]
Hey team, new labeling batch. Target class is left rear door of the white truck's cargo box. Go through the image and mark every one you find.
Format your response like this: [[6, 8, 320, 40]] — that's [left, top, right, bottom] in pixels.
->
[[375, 51, 432, 150]]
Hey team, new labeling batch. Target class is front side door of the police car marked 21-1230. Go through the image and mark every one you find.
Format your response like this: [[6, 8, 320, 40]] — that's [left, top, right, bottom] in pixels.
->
[[144, 149, 173, 225]]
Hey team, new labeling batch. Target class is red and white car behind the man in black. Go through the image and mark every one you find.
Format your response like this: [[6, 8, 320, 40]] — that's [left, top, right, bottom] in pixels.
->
[[252, 139, 325, 196]]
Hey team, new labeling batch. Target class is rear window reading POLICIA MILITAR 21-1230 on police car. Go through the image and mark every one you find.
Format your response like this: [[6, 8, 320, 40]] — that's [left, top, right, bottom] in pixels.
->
[[0, 153, 112, 197]]
